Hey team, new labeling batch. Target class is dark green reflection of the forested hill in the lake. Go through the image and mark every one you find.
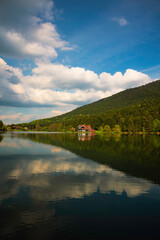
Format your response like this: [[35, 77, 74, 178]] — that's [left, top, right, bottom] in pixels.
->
[[18, 134, 160, 183]]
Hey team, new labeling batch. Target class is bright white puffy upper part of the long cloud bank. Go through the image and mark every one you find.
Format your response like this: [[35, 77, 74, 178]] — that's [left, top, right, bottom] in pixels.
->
[[27, 63, 150, 92]]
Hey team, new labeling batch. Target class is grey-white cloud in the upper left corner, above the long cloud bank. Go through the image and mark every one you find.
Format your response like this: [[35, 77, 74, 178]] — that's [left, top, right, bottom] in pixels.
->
[[0, 0, 73, 59]]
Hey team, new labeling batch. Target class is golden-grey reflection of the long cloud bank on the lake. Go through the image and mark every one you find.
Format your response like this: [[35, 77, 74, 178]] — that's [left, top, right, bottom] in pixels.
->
[[0, 158, 152, 201]]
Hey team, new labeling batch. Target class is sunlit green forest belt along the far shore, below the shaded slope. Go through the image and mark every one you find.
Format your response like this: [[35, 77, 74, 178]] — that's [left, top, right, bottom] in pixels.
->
[[8, 100, 160, 133]]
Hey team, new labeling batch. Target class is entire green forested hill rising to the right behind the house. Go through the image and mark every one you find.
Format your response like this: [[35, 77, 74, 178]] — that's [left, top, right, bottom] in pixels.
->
[[14, 80, 160, 132]]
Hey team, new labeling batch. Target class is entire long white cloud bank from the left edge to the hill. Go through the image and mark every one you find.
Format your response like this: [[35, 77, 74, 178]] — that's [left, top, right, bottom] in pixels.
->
[[0, 59, 151, 112]]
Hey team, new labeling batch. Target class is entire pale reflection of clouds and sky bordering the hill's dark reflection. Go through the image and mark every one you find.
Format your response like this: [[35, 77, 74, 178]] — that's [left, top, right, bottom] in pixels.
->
[[0, 133, 155, 204]]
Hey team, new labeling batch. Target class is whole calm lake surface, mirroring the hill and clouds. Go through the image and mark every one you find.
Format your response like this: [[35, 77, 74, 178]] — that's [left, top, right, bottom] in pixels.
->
[[0, 133, 160, 240]]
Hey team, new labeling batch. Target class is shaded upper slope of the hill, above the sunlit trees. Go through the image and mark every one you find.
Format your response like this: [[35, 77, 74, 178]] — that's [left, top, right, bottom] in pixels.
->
[[58, 80, 160, 117]]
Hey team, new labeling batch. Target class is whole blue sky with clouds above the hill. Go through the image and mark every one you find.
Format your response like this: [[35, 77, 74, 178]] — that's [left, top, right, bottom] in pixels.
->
[[0, 0, 160, 124]]
